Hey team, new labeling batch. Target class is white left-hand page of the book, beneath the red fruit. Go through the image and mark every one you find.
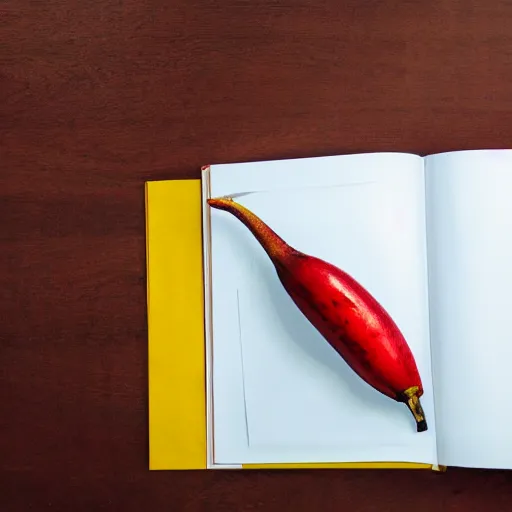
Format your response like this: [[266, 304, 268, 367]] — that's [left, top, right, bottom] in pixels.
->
[[206, 154, 436, 464]]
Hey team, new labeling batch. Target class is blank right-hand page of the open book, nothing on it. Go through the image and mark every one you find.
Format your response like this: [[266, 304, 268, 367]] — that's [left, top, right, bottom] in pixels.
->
[[426, 150, 512, 468]]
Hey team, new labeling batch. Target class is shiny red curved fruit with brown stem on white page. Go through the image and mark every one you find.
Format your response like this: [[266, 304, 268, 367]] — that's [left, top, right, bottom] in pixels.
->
[[208, 198, 427, 432]]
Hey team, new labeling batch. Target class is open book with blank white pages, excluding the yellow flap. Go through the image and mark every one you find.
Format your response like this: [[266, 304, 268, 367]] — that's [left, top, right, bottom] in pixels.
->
[[202, 150, 512, 468]]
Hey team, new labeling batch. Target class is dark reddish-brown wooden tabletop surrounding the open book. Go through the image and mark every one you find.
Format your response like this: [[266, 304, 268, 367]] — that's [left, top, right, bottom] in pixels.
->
[[0, 0, 512, 512]]
